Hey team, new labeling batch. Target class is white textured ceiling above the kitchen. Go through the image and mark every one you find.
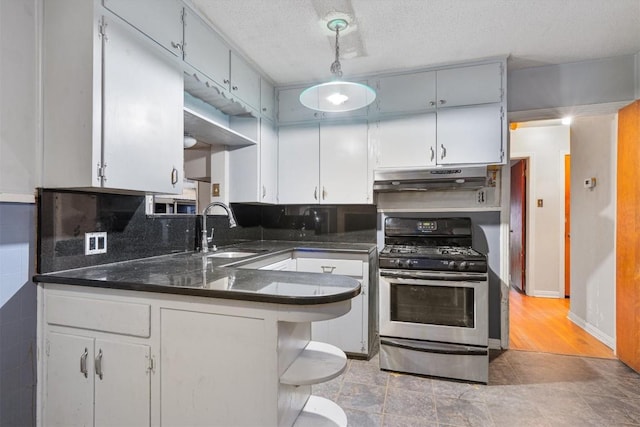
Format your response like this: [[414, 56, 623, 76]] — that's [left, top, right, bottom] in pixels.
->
[[191, 0, 640, 85]]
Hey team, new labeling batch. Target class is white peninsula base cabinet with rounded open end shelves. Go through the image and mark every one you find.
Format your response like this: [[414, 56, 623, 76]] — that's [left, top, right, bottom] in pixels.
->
[[36, 283, 351, 427]]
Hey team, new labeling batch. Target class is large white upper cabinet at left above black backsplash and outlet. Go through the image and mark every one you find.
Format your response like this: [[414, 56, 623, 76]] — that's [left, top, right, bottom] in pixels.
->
[[43, 0, 183, 194]]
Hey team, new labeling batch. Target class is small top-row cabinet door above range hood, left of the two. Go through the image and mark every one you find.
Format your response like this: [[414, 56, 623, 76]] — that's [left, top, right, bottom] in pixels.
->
[[376, 71, 436, 113]]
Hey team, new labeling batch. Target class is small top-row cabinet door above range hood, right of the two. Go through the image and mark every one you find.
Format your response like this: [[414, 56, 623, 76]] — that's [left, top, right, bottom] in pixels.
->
[[437, 62, 503, 107]]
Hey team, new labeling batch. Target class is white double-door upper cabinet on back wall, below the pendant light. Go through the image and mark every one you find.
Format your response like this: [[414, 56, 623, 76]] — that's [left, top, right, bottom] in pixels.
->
[[278, 123, 371, 204]]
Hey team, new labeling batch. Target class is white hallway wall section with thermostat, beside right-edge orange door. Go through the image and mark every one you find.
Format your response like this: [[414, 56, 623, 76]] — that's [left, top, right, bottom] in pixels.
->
[[569, 114, 617, 348]]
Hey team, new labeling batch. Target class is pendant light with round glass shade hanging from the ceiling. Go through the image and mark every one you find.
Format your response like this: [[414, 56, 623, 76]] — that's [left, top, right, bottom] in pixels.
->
[[300, 18, 376, 113]]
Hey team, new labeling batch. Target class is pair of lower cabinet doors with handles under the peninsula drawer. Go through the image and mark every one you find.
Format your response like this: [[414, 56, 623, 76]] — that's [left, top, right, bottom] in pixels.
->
[[42, 331, 151, 426]]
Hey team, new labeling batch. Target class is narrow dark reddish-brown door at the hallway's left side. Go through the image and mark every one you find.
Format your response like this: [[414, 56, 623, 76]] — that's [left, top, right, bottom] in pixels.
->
[[509, 160, 527, 293]]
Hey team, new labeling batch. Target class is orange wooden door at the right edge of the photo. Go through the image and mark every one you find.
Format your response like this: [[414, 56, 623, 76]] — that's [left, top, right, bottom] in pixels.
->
[[616, 101, 640, 372]]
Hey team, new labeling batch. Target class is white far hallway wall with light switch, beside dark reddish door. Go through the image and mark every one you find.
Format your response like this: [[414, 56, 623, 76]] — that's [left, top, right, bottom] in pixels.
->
[[510, 125, 569, 298]]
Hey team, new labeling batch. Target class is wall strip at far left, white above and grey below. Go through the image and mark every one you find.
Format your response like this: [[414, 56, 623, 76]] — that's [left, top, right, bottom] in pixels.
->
[[0, 0, 42, 426]]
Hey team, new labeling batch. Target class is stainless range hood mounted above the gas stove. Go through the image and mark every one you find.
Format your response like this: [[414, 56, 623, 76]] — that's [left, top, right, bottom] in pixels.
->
[[373, 166, 487, 193]]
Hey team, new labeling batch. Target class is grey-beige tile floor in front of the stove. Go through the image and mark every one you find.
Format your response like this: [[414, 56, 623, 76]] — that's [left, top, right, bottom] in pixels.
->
[[313, 350, 640, 427]]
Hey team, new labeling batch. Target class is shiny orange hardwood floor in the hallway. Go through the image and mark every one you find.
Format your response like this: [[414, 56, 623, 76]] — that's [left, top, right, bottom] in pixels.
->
[[509, 289, 615, 359]]
